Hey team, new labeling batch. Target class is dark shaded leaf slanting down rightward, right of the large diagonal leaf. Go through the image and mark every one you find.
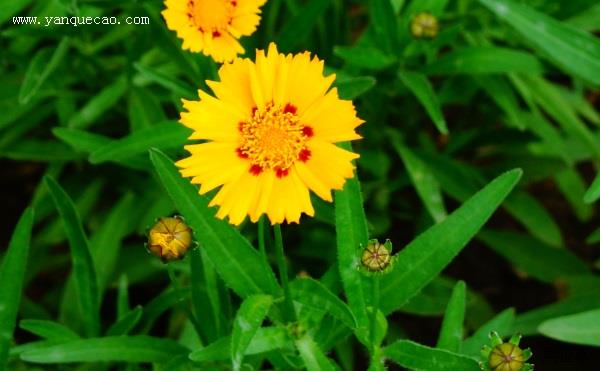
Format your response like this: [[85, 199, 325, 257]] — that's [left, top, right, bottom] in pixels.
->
[[477, 230, 589, 284]]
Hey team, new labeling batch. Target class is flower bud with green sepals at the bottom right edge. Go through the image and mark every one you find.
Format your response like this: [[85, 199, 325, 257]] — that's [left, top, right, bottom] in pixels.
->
[[480, 332, 533, 371]]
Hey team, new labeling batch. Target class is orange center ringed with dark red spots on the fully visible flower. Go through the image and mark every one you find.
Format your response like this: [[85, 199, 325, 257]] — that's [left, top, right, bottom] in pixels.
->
[[237, 103, 313, 177]]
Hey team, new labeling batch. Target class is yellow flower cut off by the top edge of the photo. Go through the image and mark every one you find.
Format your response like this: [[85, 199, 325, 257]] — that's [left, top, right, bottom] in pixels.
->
[[162, 0, 266, 62]]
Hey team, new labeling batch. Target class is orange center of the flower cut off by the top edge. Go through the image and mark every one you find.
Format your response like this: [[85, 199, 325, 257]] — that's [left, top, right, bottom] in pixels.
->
[[188, 0, 237, 37]]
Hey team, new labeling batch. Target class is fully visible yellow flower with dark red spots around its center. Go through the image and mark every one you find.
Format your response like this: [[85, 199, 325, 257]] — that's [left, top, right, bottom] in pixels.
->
[[177, 43, 363, 225]]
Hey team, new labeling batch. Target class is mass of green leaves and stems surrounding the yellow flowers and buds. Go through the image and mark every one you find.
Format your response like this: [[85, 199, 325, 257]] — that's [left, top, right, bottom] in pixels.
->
[[0, 0, 600, 371]]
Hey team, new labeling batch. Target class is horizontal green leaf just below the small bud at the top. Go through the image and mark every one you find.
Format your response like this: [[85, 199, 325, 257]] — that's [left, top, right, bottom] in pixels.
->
[[423, 46, 543, 75]]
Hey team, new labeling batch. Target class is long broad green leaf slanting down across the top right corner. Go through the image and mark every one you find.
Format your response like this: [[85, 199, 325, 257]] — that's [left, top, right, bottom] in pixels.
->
[[479, 0, 600, 85]]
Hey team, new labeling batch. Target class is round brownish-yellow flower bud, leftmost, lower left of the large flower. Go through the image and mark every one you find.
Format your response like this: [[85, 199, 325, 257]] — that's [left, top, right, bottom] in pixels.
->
[[146, 216, 192, 263]]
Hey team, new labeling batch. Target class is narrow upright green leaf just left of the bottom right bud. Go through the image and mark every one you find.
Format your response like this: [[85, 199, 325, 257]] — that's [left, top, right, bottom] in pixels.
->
[[436, 281, 467, 352]]
